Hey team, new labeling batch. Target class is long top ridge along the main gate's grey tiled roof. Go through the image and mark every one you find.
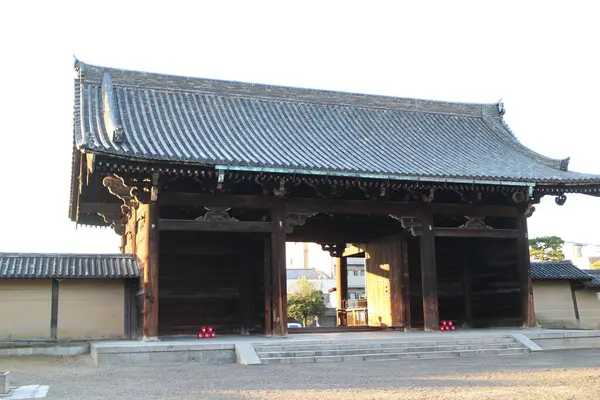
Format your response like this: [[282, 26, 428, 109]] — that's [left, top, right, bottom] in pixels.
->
[[75, 60, 499, 118]]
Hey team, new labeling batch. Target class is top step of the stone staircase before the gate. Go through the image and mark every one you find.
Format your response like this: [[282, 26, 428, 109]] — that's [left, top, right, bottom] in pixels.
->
[[253, 338, 519, 353]]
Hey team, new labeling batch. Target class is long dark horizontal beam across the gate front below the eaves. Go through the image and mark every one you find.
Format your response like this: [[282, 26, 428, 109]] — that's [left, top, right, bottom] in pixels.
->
[[161, 192, 518, 217]]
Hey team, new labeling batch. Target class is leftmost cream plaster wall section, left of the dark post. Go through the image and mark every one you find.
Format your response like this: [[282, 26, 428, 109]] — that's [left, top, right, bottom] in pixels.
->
[[0, 279, 52, 339]]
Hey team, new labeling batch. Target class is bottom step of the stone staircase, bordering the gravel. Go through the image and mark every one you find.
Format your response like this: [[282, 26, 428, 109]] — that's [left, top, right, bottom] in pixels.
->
[[261, 347, 530, 364]]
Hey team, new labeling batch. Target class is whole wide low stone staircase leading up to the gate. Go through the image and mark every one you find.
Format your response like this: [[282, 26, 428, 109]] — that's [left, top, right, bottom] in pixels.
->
[[253, 334, 530, 364]]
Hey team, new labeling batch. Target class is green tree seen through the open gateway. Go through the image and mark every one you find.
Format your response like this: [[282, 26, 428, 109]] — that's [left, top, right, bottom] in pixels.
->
[[288, 276, 325, 327]]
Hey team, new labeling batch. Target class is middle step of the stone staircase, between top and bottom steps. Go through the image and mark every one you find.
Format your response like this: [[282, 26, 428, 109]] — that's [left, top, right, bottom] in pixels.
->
[[257, 343, 525, 359]]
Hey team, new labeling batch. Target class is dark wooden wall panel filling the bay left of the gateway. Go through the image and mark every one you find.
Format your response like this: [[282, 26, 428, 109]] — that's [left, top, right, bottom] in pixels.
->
[[159, 232, 265, 335]]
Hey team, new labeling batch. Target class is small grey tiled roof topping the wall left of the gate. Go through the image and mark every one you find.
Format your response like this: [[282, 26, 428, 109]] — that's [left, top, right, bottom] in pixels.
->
[[0, 253, 139, 279]]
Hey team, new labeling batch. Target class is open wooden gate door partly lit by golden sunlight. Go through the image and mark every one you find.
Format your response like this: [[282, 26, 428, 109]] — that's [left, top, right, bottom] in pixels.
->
[[366, 235, 406, 327]]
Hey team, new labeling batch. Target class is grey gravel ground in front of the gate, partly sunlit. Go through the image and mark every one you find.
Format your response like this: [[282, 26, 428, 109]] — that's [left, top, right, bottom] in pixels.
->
[[0, 350, 600, 400]]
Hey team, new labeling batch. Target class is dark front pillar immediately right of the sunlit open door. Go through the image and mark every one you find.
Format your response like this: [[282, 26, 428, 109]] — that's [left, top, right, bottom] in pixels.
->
[[421, 212, 439, 331]]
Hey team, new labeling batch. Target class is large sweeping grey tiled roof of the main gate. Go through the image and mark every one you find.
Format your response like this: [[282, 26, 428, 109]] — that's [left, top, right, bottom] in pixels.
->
[[74, 61, 600, 184]]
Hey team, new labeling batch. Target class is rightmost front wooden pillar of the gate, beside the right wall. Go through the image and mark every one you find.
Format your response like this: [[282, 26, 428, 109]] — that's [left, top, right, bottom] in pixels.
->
[[516, 215, 535, 328]]
